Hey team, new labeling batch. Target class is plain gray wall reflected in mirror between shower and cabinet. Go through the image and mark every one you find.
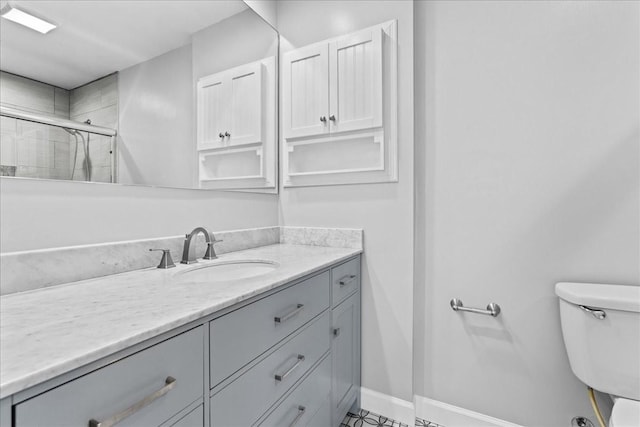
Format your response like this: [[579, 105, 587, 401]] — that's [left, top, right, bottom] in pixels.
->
[[117, 45, 192, 188]]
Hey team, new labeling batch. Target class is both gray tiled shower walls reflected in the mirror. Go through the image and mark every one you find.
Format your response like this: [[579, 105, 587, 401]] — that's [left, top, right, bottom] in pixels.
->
[[0, 72, 118, 182]]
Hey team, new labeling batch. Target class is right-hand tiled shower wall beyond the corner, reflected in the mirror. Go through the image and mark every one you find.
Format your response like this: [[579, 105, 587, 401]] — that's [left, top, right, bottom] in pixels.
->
[[69, 73, 118, 182]]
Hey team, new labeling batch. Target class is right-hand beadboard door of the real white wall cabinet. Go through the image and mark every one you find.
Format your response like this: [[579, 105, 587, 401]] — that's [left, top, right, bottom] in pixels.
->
[[329, 28, 383, 133]]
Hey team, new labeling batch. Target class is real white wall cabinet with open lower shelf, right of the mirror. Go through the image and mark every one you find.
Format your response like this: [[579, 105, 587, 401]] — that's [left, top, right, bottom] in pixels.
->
[[282, 21, 397, 186]]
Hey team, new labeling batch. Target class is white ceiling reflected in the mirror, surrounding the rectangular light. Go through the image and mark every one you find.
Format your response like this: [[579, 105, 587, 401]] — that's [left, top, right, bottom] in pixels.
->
[[0, 0, 248, 89]]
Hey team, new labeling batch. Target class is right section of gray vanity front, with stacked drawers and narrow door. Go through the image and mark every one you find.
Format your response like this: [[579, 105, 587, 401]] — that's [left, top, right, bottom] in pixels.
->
[[210, 257, 360, 427]]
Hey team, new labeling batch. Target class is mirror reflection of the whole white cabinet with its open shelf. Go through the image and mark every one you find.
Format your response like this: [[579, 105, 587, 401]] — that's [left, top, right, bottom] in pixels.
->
[[196, 57, 277, 189]]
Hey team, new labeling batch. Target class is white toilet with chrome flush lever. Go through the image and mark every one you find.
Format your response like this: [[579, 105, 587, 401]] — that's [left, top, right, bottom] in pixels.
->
[[556, 283, 640, 427]]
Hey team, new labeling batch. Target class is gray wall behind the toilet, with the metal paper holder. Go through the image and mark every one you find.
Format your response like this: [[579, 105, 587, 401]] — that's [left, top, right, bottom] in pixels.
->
[[414, 1, 640, 426]]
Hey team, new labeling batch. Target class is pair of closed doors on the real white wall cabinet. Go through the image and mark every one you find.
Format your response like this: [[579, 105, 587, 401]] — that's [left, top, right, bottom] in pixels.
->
[[284, 28, 382, 139]]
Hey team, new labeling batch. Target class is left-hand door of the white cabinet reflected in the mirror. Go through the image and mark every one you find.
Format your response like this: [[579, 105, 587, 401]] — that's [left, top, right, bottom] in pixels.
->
[[197, 72, 229, 150]]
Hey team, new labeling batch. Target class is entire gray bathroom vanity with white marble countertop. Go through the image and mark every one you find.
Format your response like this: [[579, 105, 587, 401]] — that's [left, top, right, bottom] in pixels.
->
[[0, 244, 361, 427]]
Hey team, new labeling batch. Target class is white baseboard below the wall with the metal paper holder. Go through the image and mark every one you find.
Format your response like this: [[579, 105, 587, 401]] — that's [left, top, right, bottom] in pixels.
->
[[416, 396, 522, 427]]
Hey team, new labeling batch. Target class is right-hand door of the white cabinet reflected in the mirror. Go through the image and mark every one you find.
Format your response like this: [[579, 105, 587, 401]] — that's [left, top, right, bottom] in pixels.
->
[[228, 62, 263, 145]]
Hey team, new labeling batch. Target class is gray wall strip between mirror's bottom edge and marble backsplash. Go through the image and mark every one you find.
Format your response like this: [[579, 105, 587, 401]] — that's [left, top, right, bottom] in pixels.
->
[[0, 178, 278, 252]]
